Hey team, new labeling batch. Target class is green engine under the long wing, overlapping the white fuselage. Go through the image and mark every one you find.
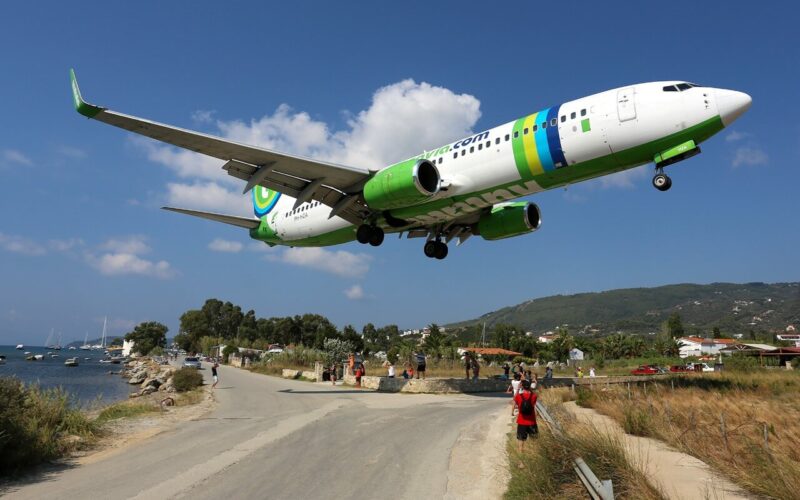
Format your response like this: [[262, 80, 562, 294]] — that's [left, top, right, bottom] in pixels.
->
[[364, 160, 442, 210]]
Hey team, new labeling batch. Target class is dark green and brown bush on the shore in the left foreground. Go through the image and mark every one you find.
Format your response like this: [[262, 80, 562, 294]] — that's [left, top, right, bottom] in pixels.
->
[[0, 377, 96, 475]]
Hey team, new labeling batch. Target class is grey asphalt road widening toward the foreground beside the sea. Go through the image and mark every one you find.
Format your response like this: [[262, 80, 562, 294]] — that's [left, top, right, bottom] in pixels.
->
[[3, 367, 508, 500]]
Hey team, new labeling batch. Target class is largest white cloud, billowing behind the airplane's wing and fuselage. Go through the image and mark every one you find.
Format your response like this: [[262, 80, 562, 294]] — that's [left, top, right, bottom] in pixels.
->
[[133, 79, 481, 215]]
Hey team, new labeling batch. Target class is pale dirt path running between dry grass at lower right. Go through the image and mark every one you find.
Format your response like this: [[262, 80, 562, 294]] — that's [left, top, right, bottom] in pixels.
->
[[564, 402, 755, 500]]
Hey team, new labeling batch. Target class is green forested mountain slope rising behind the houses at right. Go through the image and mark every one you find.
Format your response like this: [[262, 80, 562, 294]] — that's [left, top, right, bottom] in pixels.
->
[[445, 283, 800, 335]]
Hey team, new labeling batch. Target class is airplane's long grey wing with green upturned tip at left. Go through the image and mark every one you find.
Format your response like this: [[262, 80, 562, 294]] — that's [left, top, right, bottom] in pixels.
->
[[70, 70, 371, 224]]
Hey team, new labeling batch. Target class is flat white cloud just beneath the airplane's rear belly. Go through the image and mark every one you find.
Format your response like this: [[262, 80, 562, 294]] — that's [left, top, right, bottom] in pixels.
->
[[267, 248, 372, 278]]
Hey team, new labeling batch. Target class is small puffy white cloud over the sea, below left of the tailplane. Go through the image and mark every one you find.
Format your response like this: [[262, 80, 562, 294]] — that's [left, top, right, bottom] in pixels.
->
[[84, 235, 175, 279]]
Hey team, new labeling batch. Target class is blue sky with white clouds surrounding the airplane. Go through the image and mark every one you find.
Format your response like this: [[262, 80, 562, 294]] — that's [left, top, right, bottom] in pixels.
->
[[0, 1, 800, 344]]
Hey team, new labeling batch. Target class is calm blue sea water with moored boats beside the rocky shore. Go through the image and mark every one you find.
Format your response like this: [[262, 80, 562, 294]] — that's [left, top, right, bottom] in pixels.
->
[[0, 346, 134, 407]]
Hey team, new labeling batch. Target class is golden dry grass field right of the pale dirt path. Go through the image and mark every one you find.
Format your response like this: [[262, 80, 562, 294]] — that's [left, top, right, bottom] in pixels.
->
[[578, 370, 800, 498]]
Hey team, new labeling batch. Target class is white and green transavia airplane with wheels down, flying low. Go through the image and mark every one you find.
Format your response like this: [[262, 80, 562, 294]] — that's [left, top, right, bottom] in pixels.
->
[[70, 70, 752, 259]]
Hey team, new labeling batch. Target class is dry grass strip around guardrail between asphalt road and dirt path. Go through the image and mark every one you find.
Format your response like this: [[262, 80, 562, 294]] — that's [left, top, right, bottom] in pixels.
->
[[505, 389, 663, 500]]
